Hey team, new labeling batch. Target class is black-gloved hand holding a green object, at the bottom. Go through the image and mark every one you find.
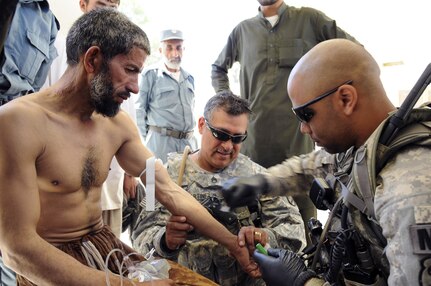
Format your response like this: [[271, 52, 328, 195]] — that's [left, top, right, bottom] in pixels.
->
[[253, 248, 316, 286]]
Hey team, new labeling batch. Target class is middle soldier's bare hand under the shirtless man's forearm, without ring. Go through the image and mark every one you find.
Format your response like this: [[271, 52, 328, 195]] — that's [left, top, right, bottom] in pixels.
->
[[165, 215, 193, 250]]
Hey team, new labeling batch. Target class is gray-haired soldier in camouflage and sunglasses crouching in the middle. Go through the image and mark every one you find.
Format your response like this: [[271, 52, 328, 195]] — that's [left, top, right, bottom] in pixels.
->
[[125, 92, 305, 286]]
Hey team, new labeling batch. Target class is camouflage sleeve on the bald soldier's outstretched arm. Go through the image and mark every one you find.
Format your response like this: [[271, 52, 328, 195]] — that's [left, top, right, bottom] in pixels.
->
[[265, 150, 335, 196]]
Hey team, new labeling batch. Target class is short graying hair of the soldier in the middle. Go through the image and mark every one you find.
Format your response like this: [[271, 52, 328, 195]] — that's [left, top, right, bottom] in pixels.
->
[[204, 90, 251, 120]]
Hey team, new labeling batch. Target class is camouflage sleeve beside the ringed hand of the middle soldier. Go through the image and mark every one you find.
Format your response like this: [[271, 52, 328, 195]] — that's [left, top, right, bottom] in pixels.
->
[[260, 196, 306, 252]]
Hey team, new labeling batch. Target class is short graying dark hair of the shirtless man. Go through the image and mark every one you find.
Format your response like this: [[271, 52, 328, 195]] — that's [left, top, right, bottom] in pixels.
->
[[66, 8, 151, 66]]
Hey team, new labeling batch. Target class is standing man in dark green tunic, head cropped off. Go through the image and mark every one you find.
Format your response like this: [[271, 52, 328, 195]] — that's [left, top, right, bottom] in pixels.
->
[[211, 0, 355, 246]]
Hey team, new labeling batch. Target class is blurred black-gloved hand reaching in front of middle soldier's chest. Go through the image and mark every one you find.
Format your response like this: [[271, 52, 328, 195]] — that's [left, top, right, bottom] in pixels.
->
[[222, 174, 268, 208]]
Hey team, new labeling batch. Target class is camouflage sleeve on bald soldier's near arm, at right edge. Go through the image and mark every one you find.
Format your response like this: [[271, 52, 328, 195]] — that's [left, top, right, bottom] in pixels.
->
[[374, 147, 431, 285]]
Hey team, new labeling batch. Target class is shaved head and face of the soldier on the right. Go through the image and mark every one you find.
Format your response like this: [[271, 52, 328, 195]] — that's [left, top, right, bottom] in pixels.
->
[[287, 39, 395, 153]]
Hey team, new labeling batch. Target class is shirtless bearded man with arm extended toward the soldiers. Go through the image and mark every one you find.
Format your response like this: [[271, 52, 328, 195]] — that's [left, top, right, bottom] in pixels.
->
[[0, 8, 258, 286]]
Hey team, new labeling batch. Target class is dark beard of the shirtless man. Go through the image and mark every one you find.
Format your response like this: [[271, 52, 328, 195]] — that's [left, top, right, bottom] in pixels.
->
[[90, 68, 120, 117]]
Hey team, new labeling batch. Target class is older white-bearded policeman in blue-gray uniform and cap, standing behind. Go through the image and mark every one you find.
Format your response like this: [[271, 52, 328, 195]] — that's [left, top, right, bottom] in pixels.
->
[[136, 29, 197, 163]]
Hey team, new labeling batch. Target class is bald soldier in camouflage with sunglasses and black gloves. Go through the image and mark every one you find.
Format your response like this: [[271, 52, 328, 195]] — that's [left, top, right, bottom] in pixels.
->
[[222, 40, 431, 286]]
